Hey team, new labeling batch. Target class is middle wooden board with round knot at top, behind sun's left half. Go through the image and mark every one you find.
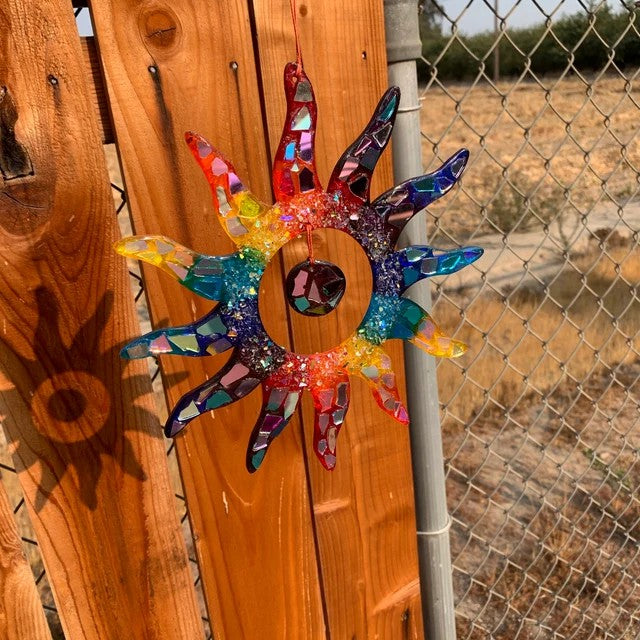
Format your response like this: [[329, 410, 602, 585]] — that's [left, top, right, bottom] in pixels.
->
[[92, 0, 324, 639]]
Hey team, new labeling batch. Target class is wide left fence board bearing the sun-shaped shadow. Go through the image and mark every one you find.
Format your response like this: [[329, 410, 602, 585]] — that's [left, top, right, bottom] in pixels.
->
[[0, 0, 202, 640]]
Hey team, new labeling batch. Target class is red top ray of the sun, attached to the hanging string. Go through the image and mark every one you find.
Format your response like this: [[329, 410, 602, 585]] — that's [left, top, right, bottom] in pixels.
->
[[272, 62, 322, 202]]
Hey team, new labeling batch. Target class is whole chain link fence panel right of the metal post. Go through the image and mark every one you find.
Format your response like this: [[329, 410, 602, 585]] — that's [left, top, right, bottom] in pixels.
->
[[420, 0, 640, 640]]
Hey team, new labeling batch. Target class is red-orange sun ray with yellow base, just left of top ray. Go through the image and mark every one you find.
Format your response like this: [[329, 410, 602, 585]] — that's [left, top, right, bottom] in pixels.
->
[[185, 131, 269, 241]]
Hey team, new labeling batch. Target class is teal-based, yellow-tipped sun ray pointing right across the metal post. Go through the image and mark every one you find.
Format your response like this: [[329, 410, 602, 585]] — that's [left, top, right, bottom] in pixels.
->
[[390, 298, 467, 358]]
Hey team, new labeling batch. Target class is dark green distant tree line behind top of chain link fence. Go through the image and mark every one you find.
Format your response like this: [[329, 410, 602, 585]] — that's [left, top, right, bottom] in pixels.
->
[[419, 0, 640, 81]]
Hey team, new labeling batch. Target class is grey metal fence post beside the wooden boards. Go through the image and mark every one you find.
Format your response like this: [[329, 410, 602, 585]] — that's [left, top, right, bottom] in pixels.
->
[[384, 0, 456, 640]]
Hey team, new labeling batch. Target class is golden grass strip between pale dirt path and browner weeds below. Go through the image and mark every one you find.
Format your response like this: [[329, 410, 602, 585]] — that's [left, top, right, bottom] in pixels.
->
[[434, 242, 640, 422]]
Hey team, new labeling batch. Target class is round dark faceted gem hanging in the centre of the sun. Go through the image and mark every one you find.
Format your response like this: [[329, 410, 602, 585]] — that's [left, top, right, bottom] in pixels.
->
[[286, 259, 347, 316]]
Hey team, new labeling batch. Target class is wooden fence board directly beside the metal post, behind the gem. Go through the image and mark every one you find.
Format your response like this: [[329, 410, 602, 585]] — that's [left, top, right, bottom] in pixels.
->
[[253, 0, 427, 639]]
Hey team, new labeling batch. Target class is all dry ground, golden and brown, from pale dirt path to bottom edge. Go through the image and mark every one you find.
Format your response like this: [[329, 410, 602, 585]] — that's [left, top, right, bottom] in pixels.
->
[[434, 185, 640, 640]]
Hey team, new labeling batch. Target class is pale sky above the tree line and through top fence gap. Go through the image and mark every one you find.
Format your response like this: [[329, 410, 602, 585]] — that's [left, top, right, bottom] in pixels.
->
[[78, 0, 596, 36]]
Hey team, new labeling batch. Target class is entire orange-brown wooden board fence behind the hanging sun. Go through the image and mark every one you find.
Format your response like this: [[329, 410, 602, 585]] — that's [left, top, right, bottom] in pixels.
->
[[0, 0, 422, 640]]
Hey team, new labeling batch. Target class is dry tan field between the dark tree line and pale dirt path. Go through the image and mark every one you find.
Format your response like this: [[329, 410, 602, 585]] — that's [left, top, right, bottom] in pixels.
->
[[421, 74, 640, 239]]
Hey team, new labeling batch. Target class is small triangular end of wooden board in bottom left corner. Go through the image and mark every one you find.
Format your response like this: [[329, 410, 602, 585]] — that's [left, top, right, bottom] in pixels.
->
[[0, 478, 51, 640]]
